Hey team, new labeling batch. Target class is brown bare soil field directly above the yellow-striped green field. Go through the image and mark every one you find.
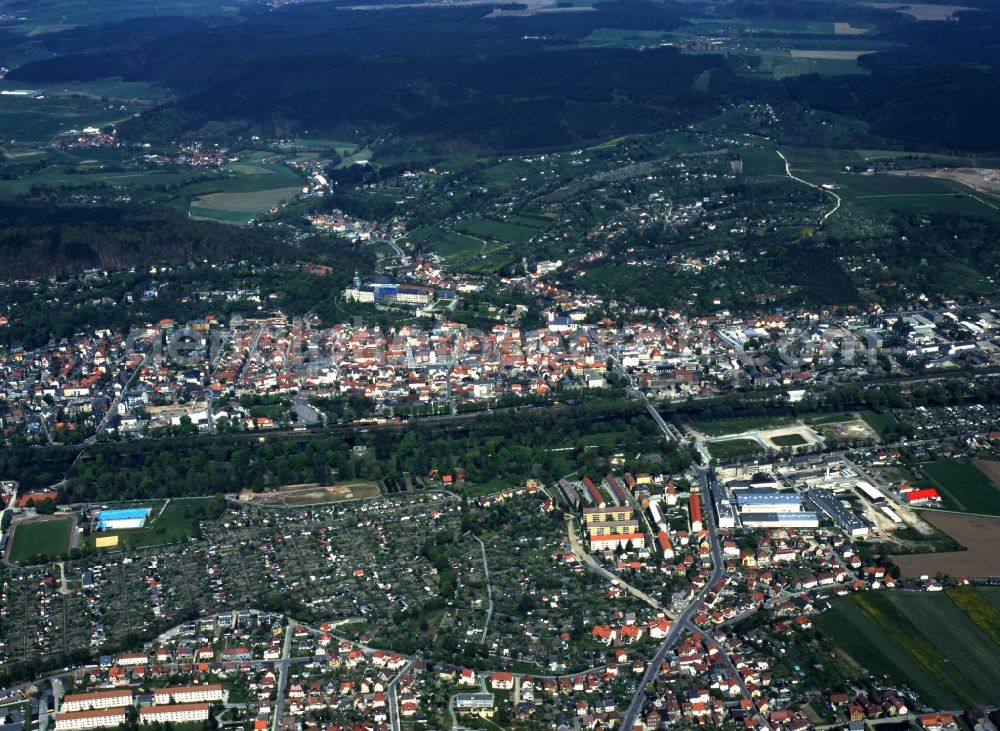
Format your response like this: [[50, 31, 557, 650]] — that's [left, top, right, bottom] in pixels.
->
[[892, 512, 1000, 579]]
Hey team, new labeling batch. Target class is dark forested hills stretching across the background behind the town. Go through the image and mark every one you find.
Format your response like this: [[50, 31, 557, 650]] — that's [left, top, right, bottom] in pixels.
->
[[0, 0, 1000, 152]]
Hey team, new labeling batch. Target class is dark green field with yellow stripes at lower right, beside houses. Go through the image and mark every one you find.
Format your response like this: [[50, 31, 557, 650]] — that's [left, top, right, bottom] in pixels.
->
[[815, 592, 1000, 708]]
